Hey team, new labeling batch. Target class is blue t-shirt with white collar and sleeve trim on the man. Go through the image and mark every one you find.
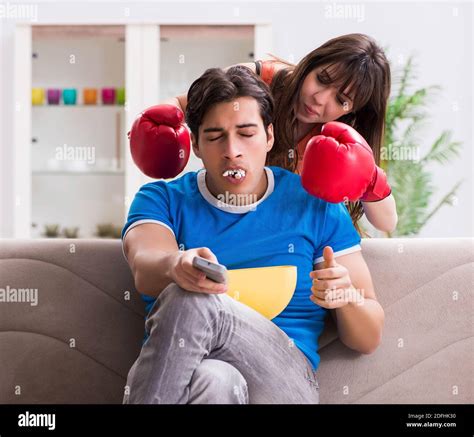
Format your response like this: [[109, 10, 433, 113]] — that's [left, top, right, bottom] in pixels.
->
[[122, 167, 360, 369]]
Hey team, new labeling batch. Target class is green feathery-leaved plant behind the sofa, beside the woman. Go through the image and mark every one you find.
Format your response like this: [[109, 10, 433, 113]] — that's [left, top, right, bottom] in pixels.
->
[[380, 57, 462, 237]]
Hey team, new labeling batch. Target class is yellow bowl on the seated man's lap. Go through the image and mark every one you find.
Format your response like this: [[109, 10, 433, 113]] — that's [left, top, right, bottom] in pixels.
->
[[227, 266, 296, 320]]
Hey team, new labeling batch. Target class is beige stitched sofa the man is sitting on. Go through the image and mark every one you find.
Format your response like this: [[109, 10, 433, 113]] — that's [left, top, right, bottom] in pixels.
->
[[0, 239, 474, 403]]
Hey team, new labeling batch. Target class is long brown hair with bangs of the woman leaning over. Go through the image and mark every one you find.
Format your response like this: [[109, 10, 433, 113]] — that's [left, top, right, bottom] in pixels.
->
[[267, 33, 391, 232]]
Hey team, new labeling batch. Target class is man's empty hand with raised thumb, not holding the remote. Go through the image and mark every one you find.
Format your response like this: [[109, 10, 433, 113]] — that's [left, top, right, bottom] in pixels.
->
[[309, 246, 364, 310]]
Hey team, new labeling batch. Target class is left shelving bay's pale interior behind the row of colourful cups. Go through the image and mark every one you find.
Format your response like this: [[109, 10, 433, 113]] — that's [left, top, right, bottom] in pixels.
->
[[31, 26, 126, 237]]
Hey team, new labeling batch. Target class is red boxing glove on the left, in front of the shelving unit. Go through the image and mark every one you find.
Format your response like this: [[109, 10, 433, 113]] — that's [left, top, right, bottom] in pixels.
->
[[128, 105, 191, 179]]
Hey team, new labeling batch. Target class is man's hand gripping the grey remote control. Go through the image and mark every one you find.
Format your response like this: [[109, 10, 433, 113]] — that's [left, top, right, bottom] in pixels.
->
[[170, 247, 227, 294]]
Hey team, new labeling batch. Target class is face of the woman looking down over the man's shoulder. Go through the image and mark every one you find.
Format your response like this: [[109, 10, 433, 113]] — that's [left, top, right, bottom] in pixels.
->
[[296, 65, 354, 123]]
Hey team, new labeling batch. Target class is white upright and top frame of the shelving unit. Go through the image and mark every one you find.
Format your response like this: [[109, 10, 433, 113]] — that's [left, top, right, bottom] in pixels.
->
[[11, 20, 273, 238]]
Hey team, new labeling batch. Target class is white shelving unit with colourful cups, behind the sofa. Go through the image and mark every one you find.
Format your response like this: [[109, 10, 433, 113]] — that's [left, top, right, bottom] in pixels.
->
[[9, 22, 272, 238]]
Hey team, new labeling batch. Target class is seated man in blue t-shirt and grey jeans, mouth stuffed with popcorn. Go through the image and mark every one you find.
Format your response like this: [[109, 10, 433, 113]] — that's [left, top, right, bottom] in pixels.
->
[[122, 66, 384, 403]]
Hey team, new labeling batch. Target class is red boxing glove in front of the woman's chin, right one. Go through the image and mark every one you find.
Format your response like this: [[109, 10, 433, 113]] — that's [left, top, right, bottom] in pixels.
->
[[301, 121, 391, 203]]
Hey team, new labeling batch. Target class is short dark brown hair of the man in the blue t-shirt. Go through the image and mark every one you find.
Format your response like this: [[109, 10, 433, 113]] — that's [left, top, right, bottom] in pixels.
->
[[186, 65, 273, 141]]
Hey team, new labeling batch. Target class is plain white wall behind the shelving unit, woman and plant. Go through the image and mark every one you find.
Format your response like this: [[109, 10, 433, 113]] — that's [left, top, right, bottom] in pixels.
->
[[0, 1, 474, 237]]
